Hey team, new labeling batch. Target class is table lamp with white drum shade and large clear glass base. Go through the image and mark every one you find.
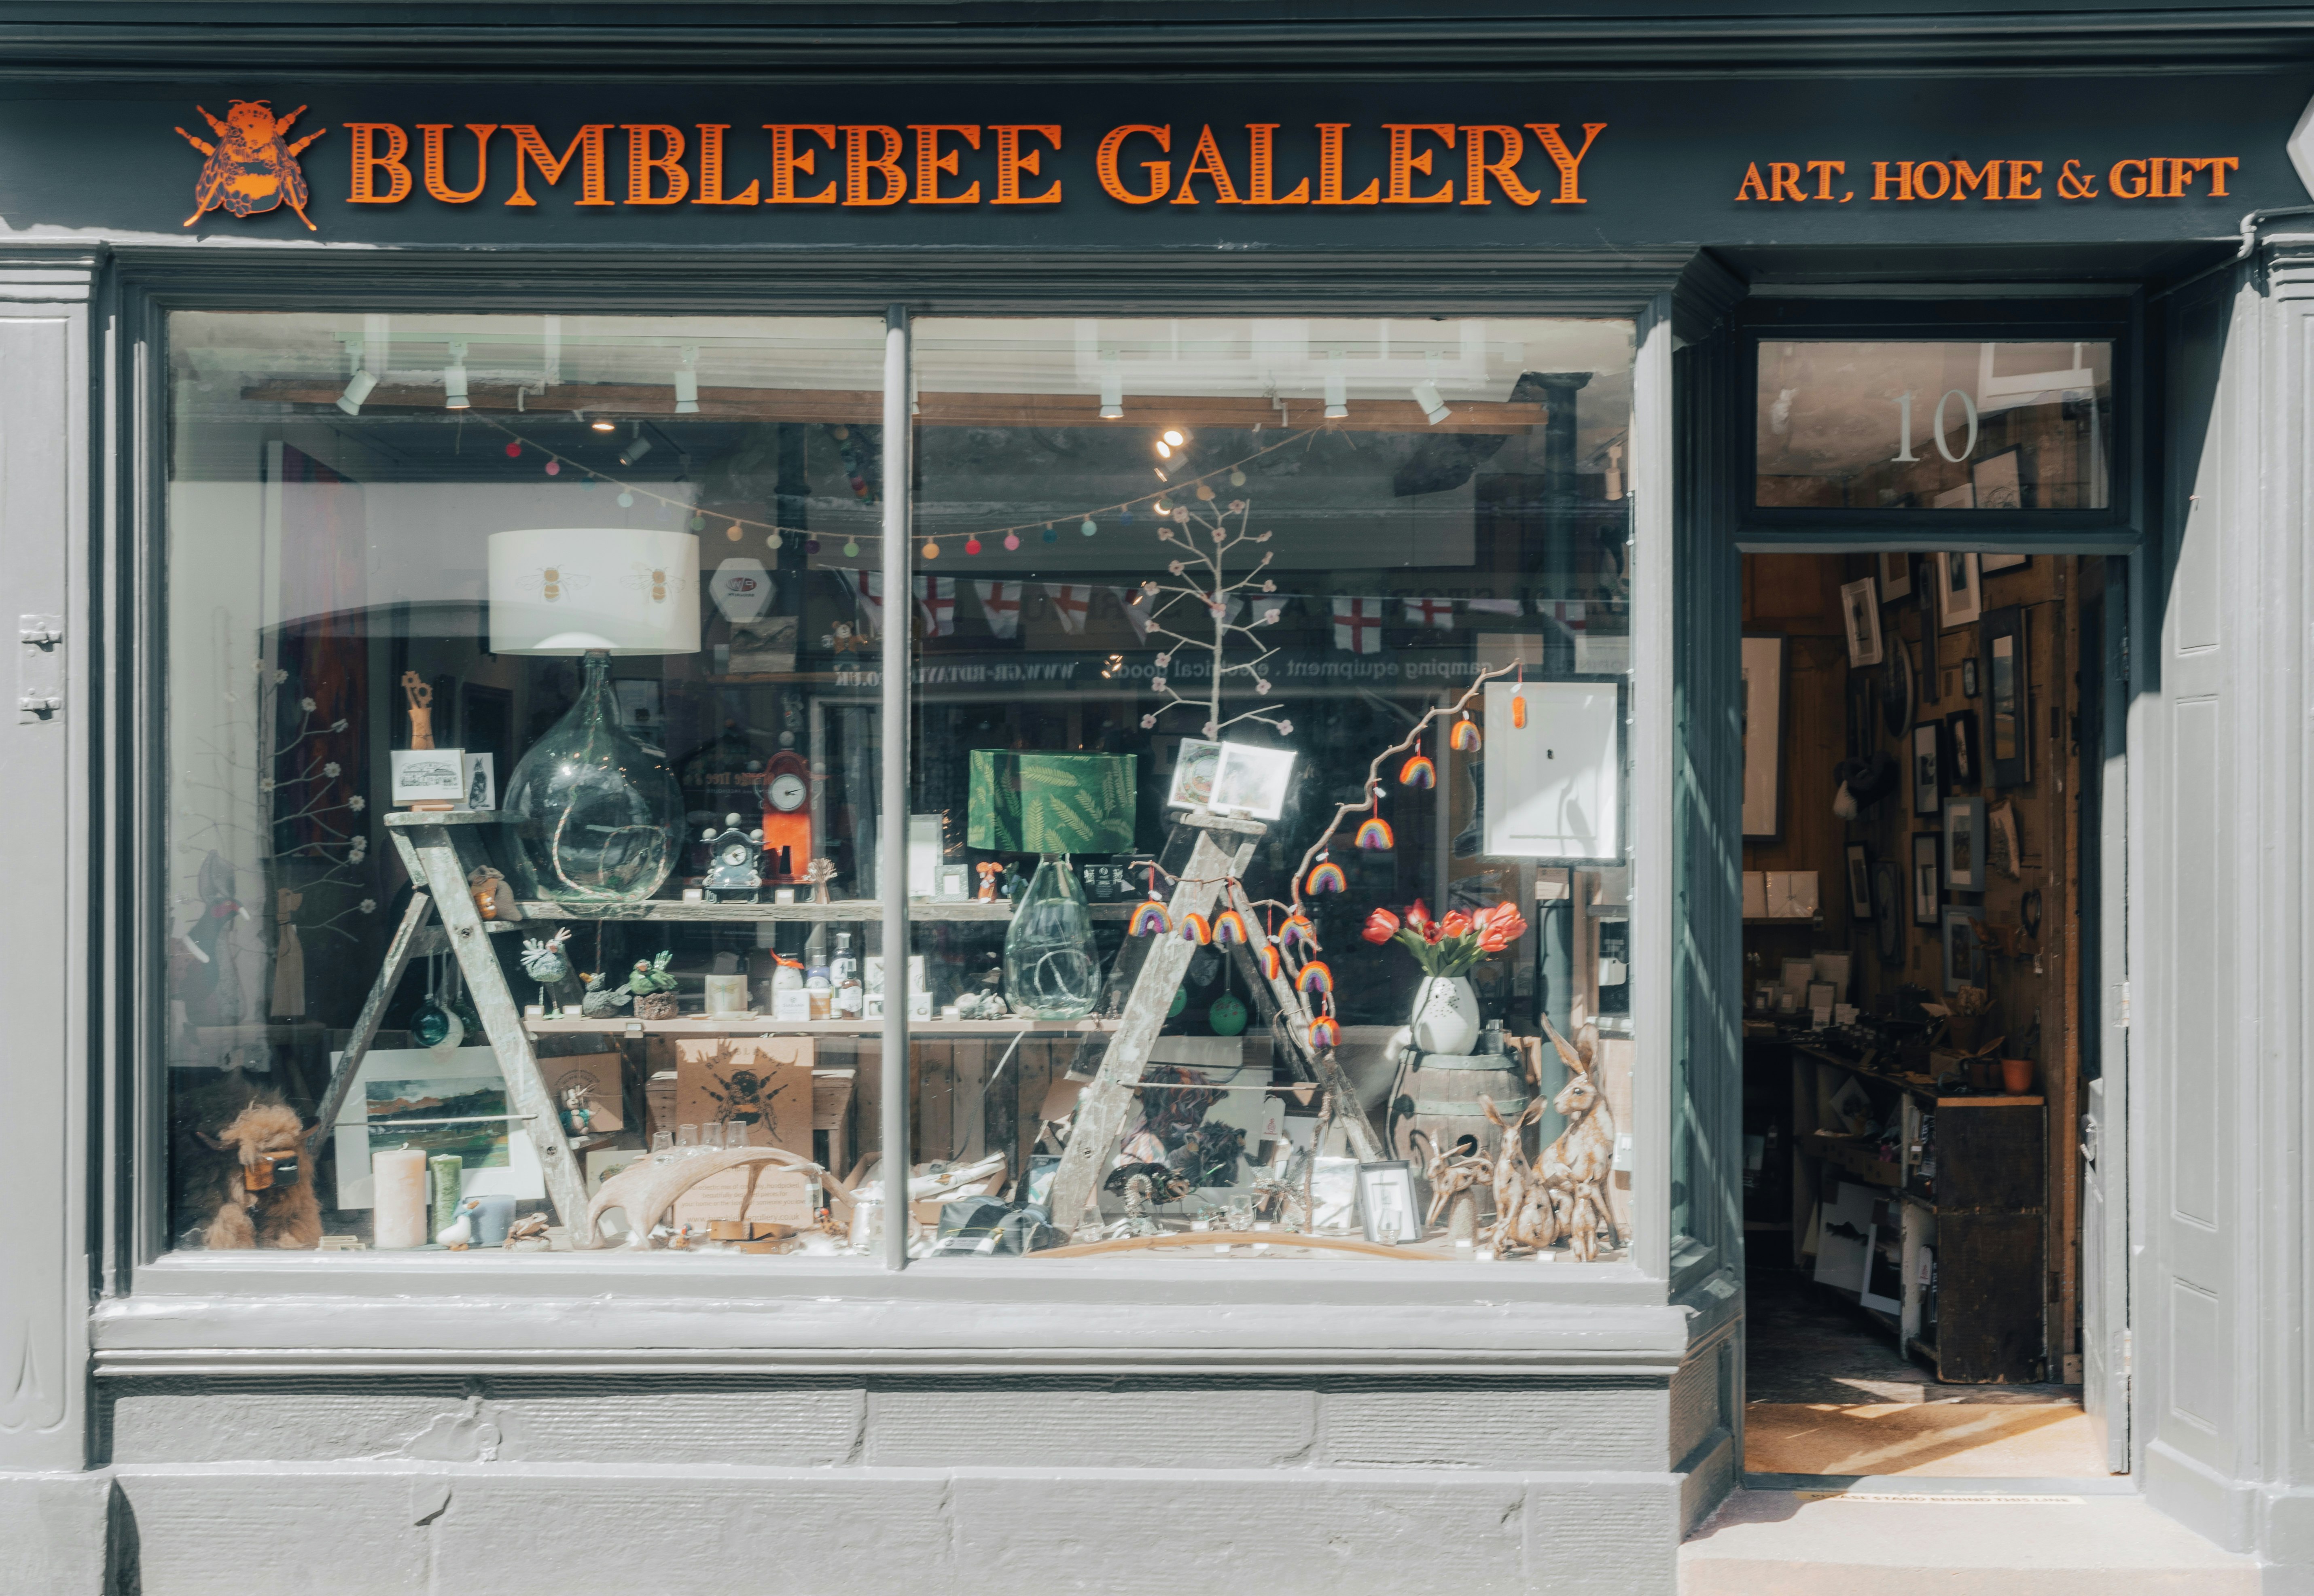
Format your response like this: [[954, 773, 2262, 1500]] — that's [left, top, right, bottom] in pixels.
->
[[491, 528, 699, 902]]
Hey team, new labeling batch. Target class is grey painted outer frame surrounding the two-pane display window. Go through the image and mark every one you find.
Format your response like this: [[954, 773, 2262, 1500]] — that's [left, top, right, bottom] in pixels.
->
[[97, 248, 1717, 1314]]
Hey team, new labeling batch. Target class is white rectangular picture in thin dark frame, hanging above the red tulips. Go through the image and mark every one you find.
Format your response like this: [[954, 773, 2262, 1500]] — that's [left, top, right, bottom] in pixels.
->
[[1485, 682, 1622, 863]]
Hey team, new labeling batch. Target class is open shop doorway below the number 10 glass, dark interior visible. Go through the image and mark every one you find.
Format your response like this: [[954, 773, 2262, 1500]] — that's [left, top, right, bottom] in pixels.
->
[[1740, 551, 2127, 1480]]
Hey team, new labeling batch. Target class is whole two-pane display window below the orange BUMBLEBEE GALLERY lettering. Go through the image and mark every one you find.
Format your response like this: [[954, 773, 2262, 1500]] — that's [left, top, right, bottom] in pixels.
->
[[162, 312, 1657, 1267]]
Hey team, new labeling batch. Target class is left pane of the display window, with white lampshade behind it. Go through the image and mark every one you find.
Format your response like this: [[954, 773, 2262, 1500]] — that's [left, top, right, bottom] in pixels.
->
[[164, 312, 884, 1256]]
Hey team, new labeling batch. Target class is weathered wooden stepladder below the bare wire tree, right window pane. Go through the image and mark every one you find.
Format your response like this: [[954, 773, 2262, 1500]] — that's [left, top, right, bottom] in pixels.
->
[[1053, 810, 1386, 1231]]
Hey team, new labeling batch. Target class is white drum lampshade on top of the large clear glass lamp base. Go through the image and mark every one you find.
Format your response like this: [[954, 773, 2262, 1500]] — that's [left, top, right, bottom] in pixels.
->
[[491, 528, 699, 655]]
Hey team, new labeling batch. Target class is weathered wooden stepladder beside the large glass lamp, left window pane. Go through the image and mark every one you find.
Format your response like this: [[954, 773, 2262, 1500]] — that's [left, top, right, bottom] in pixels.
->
[[308, 810, 588, 1247]]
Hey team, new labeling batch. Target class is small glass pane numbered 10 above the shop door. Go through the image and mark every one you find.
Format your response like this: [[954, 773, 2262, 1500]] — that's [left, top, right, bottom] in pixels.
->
[[1754, 340, 2113, 511]]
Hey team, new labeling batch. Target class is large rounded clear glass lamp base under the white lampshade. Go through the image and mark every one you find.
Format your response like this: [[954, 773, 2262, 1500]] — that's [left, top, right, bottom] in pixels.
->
[[500, 655, 685, 902]]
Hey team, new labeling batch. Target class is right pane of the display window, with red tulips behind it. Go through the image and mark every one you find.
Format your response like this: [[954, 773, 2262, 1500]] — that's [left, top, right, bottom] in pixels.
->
[[893, 319, 1634, 1261]]
